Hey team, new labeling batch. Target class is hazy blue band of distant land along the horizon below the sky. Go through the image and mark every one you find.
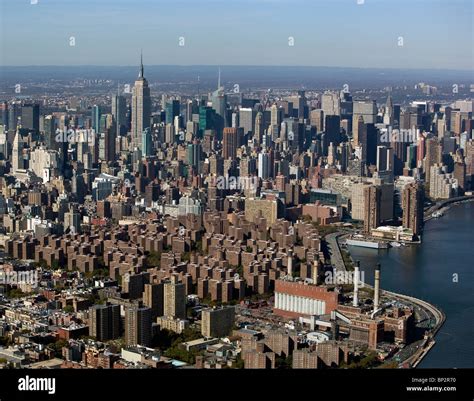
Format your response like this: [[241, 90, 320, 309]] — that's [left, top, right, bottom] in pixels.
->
[[0, 64, 473, 92]]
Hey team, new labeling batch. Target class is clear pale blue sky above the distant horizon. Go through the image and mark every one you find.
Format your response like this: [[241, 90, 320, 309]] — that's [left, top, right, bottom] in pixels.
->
[[0, 0, 474, 70]]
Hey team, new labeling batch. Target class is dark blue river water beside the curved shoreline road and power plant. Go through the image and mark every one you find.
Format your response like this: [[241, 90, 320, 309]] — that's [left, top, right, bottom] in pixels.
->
[[349, 202, 474, 368]]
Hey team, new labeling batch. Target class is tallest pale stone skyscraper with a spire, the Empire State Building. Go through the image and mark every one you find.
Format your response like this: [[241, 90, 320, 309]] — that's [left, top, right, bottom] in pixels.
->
[[132, 51, 151, 149]]
